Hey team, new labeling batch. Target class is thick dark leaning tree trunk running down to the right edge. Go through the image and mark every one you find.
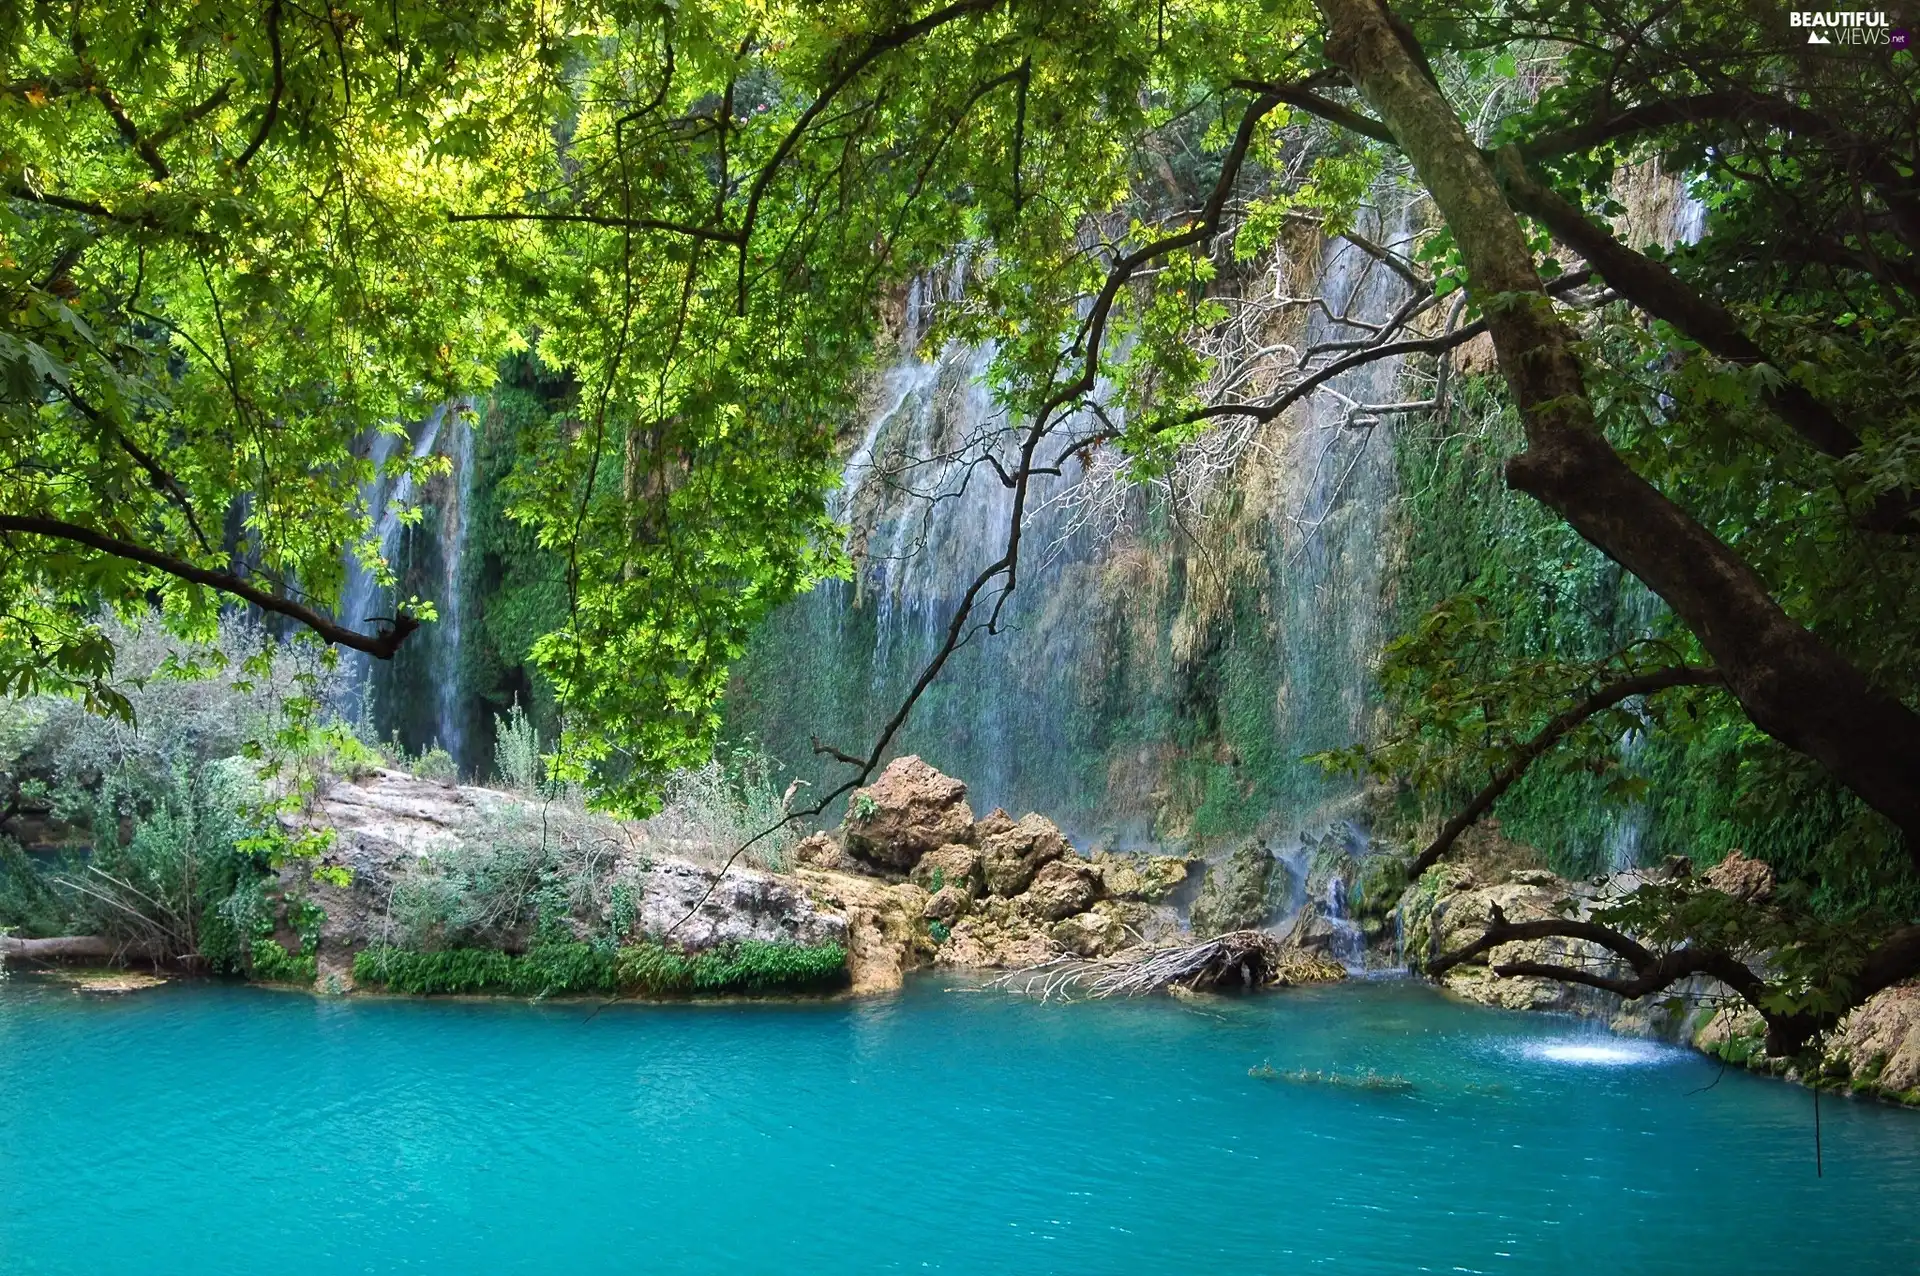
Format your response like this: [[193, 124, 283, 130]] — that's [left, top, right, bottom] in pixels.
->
[[1317, 0, 1920, 863]]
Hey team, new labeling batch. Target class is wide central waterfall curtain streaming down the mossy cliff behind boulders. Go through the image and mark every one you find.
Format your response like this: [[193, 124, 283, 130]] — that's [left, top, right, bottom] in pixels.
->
[[726, 201, 1411, 846]]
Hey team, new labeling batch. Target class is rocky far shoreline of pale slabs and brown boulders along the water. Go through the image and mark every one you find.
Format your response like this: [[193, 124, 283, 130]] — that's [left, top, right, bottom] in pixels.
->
[[0, 756, 1920, 1105]]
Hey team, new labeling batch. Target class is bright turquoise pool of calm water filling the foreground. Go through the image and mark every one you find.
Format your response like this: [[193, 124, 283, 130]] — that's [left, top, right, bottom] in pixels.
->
[[0, 977, 1920, 1276]]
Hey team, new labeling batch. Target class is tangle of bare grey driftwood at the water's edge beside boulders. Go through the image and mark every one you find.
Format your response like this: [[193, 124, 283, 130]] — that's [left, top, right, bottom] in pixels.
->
[[989, 931, 1346, 1002]]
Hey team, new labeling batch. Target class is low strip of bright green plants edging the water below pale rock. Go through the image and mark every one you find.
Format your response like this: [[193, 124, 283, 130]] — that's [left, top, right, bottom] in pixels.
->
[[353, 940, 847, 996]]
